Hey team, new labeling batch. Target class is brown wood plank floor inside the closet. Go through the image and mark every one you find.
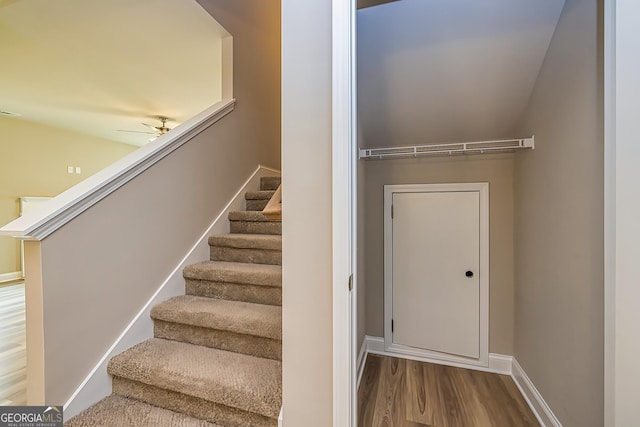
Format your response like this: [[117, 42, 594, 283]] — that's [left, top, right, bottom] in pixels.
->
[[358, 354, 539, 427]]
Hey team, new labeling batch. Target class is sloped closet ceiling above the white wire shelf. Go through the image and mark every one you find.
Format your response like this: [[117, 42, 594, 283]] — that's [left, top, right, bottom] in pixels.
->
[[358, 0, 564, 147]]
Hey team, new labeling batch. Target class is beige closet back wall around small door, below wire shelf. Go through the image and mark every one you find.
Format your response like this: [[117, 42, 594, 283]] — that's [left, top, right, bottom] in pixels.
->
[[359, 152, 516, 355]]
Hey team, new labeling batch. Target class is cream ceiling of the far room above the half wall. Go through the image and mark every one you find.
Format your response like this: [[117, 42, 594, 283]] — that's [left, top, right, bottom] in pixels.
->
[[0, 0, 228, 145]]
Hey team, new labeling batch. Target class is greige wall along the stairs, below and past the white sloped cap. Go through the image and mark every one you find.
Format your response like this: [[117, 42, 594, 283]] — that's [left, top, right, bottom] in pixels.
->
[[41, 0, 280, 404]]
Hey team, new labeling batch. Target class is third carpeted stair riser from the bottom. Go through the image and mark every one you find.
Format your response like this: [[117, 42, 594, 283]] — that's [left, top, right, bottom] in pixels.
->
[[185, 279, 282, 305]]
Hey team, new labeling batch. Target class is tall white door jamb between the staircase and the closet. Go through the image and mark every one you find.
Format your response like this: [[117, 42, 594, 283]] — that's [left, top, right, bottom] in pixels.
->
[[331, 0, 358, 427]]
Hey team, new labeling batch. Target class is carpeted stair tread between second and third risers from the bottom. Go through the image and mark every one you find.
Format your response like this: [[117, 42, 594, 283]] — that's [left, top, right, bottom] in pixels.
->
[[151, 295, 282, 340]]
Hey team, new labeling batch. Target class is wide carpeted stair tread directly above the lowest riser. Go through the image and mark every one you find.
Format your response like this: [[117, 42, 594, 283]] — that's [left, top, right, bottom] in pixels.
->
[[108, 338, 282, 418]]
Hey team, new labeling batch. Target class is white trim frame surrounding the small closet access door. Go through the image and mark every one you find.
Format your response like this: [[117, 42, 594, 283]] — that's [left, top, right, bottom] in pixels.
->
[[384, 182, 490, 367]]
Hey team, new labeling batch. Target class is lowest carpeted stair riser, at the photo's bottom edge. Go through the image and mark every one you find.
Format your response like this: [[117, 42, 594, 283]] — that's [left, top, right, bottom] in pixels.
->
[[112, 377, 278, 427]]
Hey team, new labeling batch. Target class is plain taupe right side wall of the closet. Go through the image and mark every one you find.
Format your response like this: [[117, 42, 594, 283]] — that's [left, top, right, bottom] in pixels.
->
[[515, 0, 603, 427]]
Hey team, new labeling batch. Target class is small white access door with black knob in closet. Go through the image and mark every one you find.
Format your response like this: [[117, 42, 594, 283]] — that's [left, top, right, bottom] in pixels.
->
[[387, 184, 488, 359]]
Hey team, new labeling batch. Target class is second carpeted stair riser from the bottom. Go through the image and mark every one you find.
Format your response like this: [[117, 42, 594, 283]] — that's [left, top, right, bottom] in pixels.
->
[[154, 320, 282, 360]]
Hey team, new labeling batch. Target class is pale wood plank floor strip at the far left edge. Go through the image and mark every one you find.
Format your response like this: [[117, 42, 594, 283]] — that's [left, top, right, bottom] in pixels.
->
[[0, 283, 27, 406]]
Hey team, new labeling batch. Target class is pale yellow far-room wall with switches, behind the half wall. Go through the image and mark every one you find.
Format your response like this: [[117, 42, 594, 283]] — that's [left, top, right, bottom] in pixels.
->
[[0, 116, 138, 274]]
